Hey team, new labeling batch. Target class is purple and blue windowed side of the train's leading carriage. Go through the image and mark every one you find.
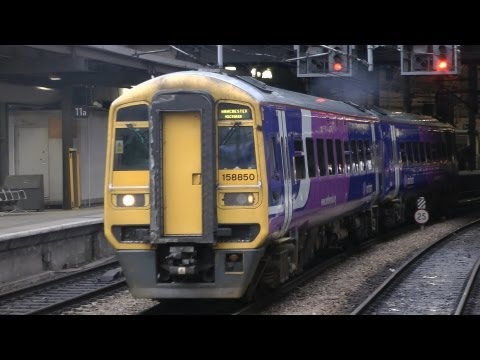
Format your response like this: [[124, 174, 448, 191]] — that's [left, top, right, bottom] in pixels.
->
[[262, 105, 380, 246]]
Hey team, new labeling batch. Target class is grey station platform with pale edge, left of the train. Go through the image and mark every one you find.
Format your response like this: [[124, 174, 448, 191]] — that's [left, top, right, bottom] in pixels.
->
[[0, 206, 114, 286]]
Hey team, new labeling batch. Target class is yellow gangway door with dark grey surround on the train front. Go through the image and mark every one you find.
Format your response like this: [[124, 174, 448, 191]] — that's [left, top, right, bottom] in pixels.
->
[[149, 91, 217, 244]]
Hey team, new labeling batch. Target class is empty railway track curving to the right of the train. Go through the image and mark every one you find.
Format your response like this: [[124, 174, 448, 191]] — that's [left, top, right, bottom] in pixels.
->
[[352, 220, 480, 315]]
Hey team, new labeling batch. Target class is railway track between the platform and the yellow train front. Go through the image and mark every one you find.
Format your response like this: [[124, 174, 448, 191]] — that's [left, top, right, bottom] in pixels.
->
[[0, 260, 126, 315]]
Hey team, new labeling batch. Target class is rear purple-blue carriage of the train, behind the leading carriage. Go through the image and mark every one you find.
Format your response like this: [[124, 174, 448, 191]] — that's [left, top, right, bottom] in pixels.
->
[[372, 109, 458, 228]]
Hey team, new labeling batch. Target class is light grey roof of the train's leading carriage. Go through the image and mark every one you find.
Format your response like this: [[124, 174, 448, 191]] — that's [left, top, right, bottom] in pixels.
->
[[152, 70, 377, 120]]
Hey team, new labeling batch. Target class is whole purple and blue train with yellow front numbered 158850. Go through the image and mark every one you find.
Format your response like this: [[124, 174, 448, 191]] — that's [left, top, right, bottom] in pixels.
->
[[104, 70, 458, 299]]
